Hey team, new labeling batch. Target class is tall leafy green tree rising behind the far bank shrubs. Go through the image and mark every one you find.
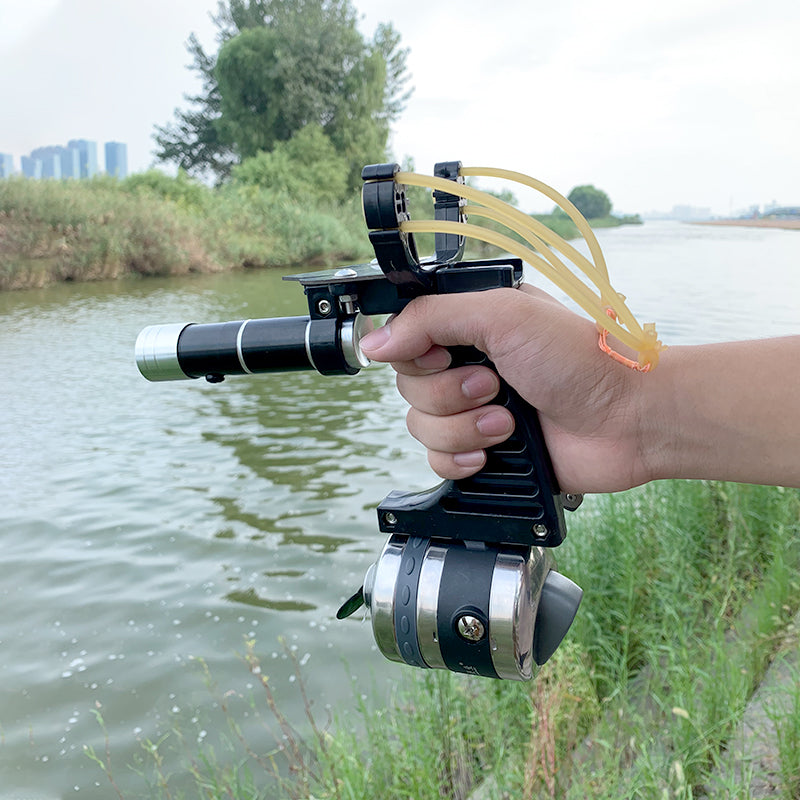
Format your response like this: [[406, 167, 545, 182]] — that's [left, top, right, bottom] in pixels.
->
[[154, 0, 409, 185]]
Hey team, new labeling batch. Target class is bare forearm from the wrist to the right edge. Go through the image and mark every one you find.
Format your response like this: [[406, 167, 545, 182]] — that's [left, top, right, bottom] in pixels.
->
[[639, 336, 800, 487]]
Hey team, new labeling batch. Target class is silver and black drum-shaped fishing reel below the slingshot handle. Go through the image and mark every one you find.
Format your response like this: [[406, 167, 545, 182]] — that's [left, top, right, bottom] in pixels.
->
[[363, 534, 583, 680]]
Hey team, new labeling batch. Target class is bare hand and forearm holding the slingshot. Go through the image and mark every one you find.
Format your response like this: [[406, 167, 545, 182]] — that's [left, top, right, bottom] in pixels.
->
[[361, 286, 800, 492]]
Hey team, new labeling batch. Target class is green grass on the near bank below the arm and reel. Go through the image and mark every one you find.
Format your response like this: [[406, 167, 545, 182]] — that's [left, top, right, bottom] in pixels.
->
[[87, 482, 800, 800]]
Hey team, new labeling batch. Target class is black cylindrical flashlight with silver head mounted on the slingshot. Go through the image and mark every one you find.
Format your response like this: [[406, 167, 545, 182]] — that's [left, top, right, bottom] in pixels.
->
[[136, 314, 369, 381]]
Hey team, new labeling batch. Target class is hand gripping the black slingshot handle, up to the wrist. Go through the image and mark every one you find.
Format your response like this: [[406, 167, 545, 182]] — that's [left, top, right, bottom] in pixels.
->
[[361, 286, 652, 492]]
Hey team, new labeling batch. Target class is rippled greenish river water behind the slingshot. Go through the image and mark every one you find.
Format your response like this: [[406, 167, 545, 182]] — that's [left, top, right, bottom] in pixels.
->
[[0, 223, 800, 800]]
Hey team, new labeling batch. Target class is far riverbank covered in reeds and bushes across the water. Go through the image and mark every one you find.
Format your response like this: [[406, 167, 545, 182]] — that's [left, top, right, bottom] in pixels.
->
[[0, 171, 640, 290]]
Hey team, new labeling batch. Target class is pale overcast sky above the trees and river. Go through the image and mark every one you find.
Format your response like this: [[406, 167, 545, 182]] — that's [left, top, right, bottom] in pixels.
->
[[0, 0, 800, 214]]
